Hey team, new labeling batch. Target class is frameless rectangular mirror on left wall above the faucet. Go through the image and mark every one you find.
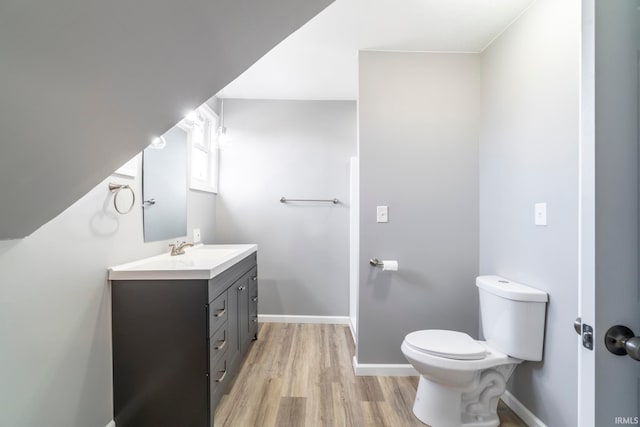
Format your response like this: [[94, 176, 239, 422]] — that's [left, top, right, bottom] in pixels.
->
[[142, 126, 188, 242]]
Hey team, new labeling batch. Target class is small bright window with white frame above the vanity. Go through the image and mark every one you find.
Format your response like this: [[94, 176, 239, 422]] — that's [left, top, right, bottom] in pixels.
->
[[180, 104, 218, 193]]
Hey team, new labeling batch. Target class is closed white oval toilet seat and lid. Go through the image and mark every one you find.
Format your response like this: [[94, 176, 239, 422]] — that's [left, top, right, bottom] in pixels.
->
[[405, 329, 487, 360]]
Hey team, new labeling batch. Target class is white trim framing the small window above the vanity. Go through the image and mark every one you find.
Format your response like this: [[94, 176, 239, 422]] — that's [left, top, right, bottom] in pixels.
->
[[178, 104, 219, 194]]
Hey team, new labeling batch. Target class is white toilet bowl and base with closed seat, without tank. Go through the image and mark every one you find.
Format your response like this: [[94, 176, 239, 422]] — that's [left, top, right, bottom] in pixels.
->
[[401, 329, 522, 427]]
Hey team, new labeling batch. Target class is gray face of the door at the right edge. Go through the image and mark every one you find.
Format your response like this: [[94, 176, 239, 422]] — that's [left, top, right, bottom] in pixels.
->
[[595, 0, 640, 427]]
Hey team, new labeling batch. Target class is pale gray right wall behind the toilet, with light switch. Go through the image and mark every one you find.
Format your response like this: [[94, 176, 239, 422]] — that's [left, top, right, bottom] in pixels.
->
[[480, 0, 580, 426]]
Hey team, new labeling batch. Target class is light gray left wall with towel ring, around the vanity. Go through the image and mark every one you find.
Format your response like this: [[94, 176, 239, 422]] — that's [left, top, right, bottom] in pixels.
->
[[0, 157, 215, 427]]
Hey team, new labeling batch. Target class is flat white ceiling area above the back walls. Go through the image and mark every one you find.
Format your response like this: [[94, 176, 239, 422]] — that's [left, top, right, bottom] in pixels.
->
[[218, 0, 534, 99]]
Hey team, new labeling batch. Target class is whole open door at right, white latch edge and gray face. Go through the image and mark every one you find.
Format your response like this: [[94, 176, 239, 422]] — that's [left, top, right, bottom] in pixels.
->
[[578, 0, 640, 427]]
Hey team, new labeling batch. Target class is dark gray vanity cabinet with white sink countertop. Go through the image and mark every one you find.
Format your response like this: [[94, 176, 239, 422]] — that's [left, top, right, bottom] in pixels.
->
[[109, 245, 258, 427]]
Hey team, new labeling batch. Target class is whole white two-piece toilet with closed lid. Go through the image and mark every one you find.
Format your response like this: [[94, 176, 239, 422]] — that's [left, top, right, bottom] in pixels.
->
[[402, 276, 548, 427]]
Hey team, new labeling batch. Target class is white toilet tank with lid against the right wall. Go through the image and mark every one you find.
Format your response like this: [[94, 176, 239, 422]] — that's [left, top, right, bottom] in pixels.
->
[[476, 276, 548, 361]]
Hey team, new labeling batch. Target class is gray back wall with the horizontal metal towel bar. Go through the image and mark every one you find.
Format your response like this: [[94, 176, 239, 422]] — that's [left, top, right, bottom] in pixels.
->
[[216, 99, 356, 316]]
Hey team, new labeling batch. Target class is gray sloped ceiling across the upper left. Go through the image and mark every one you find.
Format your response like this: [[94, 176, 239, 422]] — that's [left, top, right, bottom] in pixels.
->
[[0, 0, 332, 239]]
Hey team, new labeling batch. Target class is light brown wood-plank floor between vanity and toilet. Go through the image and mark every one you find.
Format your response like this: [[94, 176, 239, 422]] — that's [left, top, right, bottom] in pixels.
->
[[215, 323, 526, 427]]
